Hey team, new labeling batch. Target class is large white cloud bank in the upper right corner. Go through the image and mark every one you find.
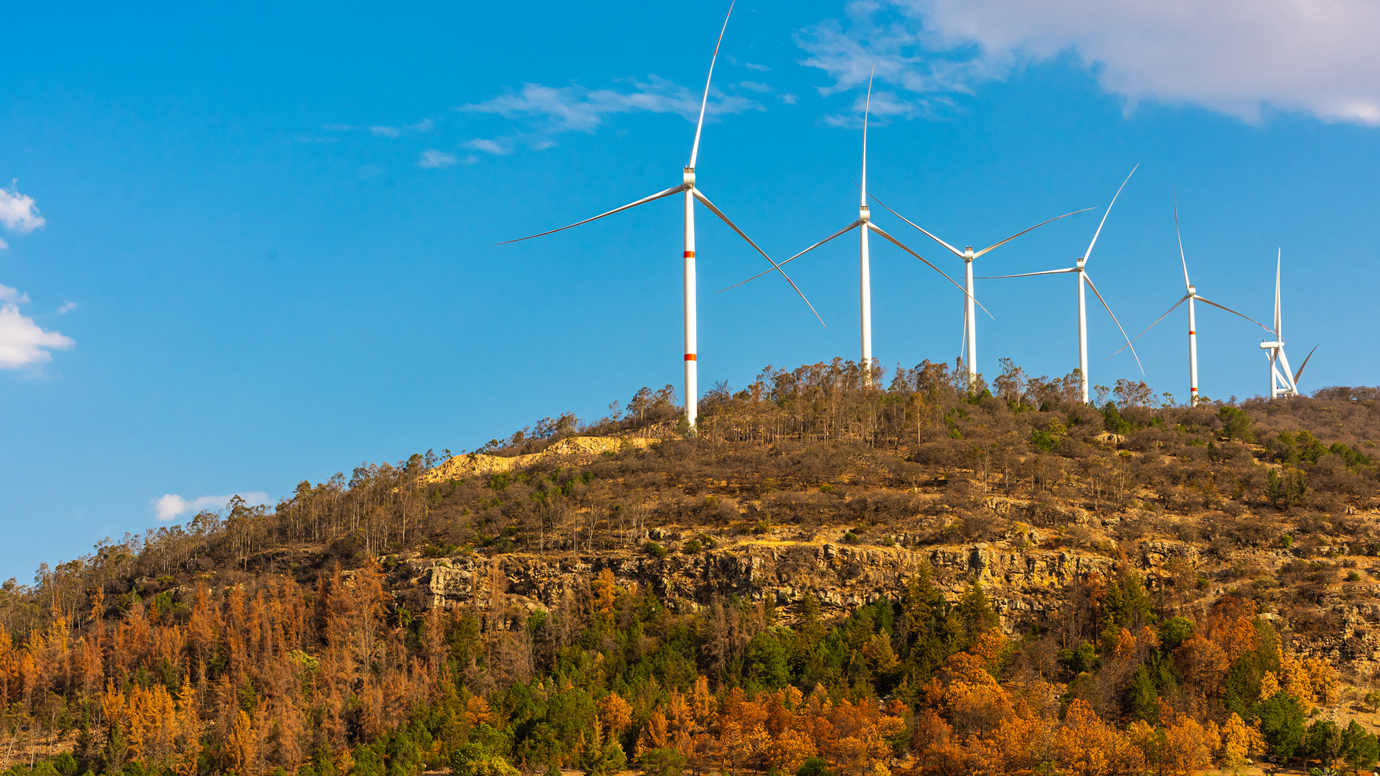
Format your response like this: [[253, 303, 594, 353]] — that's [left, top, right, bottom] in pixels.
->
[[798, 0, 1380, 126]]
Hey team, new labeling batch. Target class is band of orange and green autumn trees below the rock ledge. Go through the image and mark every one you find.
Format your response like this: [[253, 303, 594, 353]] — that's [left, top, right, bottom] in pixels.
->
[[0, 552, 1376, 776]]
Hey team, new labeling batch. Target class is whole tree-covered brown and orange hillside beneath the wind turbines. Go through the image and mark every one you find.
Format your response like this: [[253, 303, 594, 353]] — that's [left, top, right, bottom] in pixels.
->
[[0, 362, 1380, 776]]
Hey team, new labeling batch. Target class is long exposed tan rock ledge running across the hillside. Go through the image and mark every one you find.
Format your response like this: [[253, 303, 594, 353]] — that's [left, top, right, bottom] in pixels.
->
[[406, 541, 1112, 625]]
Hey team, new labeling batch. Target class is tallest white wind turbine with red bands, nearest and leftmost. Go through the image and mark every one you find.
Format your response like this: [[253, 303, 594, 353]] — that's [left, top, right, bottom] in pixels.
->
[[498, 3, 824, 429]]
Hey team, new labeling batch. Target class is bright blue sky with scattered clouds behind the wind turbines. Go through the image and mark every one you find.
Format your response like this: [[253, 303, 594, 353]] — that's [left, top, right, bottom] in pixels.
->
[[0, 0, 1380, 581]]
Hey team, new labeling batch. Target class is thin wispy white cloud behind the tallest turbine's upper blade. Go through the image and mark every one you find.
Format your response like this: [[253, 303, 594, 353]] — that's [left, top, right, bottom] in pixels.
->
[[460, 76, 762, 134]]
